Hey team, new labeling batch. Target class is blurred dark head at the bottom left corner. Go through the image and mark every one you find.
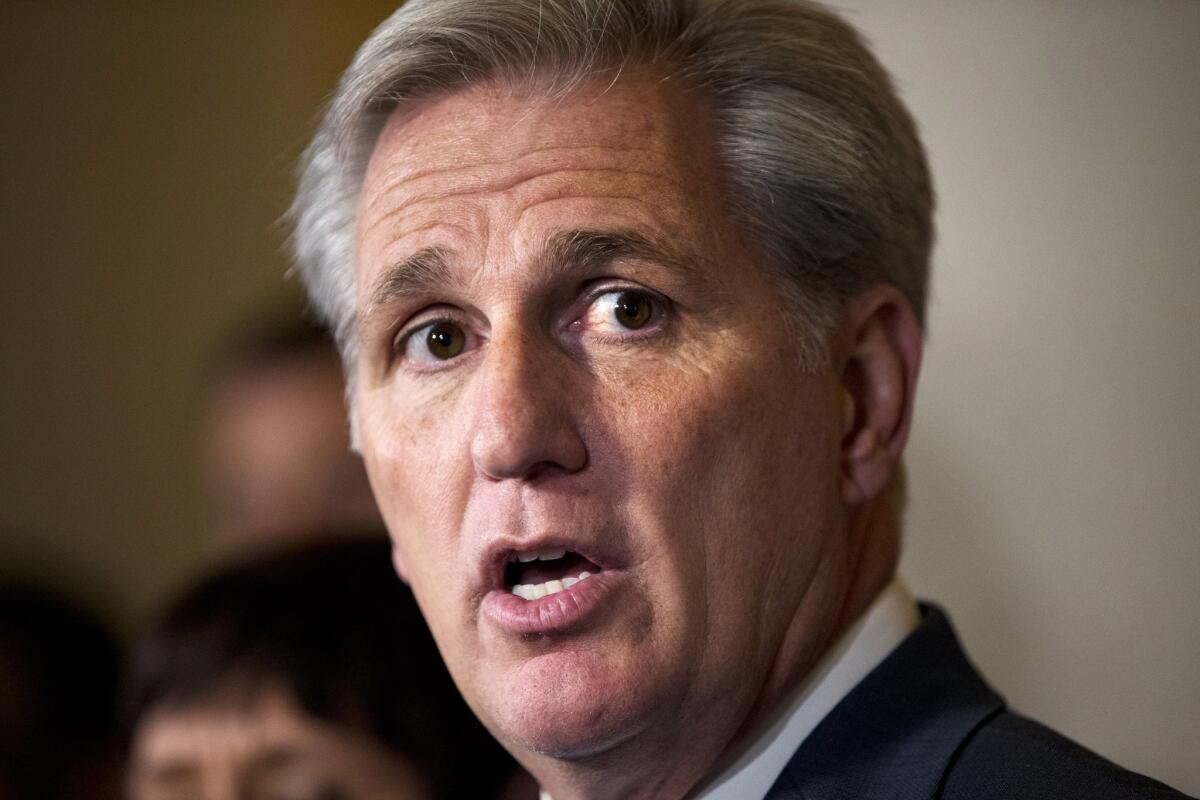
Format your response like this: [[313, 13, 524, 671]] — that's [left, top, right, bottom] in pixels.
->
[[0, 585, 121, 800]]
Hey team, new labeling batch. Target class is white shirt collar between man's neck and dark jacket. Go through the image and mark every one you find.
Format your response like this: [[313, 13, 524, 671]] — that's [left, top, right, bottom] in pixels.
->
[[540, 578, 920, 800]]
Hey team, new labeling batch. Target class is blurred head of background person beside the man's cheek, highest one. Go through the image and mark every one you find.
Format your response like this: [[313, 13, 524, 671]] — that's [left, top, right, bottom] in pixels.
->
[[204, 311, 382, 548]]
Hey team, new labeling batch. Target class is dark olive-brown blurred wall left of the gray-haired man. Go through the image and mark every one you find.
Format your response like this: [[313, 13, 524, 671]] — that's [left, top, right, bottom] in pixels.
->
[[0, 0, 398, 627]]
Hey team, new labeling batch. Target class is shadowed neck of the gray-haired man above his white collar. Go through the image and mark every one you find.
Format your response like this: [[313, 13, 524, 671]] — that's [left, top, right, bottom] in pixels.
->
[[526, 499, 900, 800]]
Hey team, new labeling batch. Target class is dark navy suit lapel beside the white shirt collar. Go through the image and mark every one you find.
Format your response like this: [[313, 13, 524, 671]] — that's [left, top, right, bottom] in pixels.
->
[[767, 606, 1004, 800]]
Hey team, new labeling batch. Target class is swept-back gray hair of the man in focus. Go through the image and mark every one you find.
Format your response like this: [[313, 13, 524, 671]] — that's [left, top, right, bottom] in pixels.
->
[[290, 0, 934, 381]]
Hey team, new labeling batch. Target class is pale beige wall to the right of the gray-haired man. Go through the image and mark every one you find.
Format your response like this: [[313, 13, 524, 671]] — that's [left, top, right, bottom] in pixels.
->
[[839, 0, 1200, 794]]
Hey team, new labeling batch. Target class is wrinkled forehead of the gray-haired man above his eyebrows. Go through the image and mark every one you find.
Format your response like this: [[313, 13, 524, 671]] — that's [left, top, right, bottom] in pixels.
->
[[358, 77, 718, 281]]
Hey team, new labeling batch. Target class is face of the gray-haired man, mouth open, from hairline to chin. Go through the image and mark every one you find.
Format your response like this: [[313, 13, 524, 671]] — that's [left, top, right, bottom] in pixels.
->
[[355, 80, 841, 757]]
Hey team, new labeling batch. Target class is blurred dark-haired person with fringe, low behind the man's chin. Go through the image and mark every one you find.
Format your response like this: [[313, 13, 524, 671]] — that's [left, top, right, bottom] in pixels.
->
[[125, 537, 533, 800]]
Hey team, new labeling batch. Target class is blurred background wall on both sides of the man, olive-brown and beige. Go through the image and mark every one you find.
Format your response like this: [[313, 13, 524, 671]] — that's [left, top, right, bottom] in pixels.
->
[[0, 0, 1200, 794]]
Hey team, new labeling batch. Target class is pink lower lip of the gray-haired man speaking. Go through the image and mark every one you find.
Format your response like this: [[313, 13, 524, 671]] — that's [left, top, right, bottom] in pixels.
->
[[480, 570, 624, 636]]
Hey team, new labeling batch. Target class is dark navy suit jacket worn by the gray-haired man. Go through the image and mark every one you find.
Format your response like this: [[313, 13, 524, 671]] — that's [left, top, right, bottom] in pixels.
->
[[767, 606, 1184, 800]]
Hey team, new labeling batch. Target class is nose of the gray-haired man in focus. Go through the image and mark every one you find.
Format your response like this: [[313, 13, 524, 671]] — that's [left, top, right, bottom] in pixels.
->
[[470, 335, 588, 481]]
